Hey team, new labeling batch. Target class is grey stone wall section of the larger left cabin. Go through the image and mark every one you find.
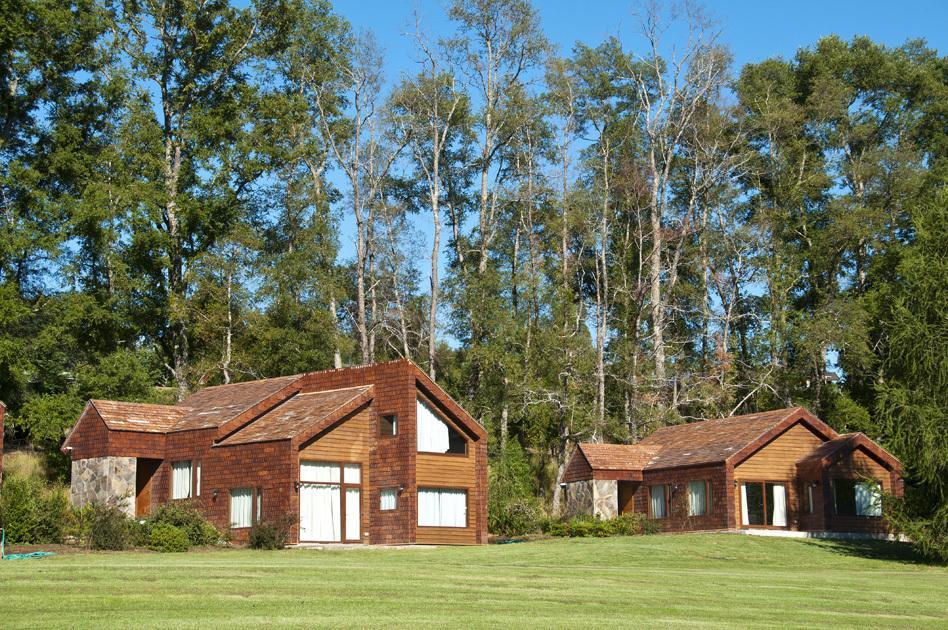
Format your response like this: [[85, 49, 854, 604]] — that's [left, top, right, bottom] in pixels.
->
[[69, 457, 135, 516]]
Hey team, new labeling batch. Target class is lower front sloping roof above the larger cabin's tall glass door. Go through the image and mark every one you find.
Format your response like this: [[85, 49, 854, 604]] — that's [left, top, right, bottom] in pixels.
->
[[215, 385, 372, 446]]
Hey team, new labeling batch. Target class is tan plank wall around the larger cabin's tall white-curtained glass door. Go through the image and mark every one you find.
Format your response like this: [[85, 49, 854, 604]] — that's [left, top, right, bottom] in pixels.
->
[[292, 407, 378, 543]]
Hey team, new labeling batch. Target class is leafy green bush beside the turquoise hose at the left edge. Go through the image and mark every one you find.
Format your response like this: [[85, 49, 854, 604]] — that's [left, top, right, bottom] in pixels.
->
[[0, 474, 71, 544]]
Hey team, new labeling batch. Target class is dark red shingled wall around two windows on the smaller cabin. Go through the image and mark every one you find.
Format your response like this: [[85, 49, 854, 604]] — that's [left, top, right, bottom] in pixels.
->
[[634, 464, 732, 532]]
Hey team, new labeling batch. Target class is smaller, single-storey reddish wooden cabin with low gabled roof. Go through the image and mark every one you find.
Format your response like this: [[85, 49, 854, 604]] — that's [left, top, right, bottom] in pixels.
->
[[560, 407, 902, 533]]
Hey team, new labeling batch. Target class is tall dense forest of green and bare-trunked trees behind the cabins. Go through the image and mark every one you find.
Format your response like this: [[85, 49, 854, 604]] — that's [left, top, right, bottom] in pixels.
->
[[0, 0, 948, 544]]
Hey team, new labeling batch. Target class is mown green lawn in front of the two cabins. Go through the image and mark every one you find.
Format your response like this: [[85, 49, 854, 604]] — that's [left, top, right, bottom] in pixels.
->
[[0, 534, 948, 629]]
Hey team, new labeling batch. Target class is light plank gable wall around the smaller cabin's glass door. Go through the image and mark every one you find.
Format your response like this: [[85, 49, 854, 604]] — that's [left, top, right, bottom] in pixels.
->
[[733, 423, 824, 530]]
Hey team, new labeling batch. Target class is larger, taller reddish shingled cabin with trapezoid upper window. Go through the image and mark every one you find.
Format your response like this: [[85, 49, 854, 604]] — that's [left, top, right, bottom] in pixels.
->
[[62, 360, 487, 545]]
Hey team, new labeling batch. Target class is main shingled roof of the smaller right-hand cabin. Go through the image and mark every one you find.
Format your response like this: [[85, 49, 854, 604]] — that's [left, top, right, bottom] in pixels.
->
[[639, 407, 836, 469]]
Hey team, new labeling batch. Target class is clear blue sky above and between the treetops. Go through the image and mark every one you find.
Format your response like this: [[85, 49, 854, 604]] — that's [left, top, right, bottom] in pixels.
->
[[333, 0, 948, 274]]
